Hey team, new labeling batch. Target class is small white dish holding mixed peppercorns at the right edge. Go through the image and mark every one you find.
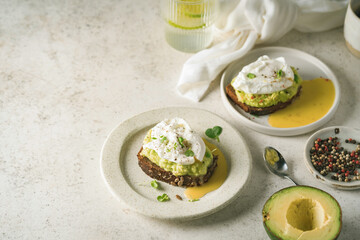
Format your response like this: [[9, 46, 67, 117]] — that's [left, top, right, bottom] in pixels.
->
[[304, 126, 360, 190]]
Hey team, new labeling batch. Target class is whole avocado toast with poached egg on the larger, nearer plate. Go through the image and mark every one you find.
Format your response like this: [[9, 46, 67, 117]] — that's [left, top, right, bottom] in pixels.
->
[[137, 118, 217, 187]]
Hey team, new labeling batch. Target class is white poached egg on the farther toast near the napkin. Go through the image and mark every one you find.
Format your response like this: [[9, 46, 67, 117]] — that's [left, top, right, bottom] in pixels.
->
[[232, 55, 294, 94]]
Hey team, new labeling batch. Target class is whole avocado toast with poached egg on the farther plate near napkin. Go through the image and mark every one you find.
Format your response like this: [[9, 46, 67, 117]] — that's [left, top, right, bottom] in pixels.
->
[[225, 56, 302, 115]]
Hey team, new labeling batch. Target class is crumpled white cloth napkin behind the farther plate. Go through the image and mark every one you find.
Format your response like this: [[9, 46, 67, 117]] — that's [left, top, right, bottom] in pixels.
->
[[177, 0, 348, 101]]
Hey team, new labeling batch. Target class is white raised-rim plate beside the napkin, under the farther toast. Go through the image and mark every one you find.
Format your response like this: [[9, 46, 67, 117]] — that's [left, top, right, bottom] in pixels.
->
[[220, 47, 340, 136]]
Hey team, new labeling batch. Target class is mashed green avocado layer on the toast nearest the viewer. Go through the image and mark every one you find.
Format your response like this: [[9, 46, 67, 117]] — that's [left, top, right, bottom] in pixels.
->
[[141, 130, 213, 176]]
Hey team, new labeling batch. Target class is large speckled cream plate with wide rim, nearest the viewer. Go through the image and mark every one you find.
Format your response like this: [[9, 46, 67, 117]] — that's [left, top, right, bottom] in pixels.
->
[[101, 107, 251, 219]]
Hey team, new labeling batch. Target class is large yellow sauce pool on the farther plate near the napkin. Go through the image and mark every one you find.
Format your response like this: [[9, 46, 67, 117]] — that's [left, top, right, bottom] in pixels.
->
[[268, 78, 335, 128]]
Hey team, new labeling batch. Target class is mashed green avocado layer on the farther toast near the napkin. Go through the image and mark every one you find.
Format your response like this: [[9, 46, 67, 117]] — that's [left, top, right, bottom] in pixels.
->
[[231, 67, 302, 107]]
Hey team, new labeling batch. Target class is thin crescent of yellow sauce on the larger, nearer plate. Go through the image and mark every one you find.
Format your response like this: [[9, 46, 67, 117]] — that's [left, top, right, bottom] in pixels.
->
[[185, 139, 227, 200]]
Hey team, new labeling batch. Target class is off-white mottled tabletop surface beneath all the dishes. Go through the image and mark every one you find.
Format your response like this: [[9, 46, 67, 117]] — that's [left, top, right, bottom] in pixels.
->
[[0, 0, 360, 239]]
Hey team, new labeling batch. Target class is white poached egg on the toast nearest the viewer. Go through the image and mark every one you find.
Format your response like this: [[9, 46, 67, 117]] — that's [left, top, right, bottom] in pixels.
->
[[143, 118, 206, 165]]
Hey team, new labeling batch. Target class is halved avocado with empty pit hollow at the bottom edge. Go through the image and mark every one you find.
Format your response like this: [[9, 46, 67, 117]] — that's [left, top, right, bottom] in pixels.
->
[[262, 186, 342, 240]]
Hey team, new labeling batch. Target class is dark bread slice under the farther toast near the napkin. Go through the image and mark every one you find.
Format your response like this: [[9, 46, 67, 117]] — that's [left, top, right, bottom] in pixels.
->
[[226, 84, 301, 116]]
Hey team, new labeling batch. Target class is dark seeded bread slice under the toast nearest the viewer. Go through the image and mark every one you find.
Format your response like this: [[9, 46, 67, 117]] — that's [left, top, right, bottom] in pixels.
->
[[137, 148, 218, 187]]
